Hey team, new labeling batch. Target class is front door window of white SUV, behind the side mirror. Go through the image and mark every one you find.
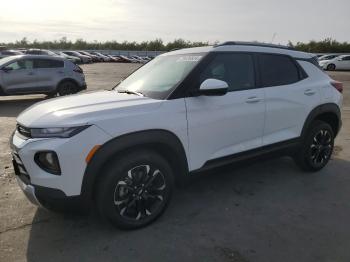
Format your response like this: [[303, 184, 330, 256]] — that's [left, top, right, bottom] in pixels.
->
[[199, 53, 255, 91]]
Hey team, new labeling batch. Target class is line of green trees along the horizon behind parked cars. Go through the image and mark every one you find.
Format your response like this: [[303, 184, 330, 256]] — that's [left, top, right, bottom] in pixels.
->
[[0, 37, 350, 53]]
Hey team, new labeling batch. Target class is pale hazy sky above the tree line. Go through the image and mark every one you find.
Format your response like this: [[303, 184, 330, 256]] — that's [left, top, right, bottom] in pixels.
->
[[0, 0, 350, 44]]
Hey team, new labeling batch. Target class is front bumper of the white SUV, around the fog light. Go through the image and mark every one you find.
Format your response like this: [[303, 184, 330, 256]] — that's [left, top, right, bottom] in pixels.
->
[[11, 125, 110, 196]]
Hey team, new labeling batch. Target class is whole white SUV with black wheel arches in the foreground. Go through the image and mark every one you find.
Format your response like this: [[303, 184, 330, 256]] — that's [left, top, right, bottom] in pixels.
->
[[11, 42, 342, 228]]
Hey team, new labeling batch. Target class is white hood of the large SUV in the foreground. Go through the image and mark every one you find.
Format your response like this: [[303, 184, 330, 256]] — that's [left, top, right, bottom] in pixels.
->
[[17, 91, 162, 128]]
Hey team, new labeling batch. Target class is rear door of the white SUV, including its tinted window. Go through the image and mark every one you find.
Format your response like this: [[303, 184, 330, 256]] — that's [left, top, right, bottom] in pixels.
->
[[258, 54, 321, 145]]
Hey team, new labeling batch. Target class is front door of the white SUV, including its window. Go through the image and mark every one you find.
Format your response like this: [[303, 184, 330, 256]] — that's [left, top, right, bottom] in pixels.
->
[[185, 53, 265, 170]]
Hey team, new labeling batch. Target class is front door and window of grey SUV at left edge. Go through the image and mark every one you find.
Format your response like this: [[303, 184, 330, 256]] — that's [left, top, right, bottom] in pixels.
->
[[2, 59, 36, 95]]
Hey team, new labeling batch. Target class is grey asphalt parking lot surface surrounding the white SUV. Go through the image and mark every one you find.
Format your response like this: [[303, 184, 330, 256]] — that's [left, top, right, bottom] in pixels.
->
[[0, 63, 350, 262]]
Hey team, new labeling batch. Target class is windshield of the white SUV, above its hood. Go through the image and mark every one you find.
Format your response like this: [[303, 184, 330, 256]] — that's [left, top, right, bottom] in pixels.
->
[[116, 54, 203, 99]]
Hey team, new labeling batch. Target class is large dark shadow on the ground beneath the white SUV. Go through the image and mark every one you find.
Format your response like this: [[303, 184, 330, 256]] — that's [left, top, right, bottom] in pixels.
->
[[27, 158, 350, 261]]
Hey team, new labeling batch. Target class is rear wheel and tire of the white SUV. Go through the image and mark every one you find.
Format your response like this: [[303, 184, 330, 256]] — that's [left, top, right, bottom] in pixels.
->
[[294, 120, 334, 172]]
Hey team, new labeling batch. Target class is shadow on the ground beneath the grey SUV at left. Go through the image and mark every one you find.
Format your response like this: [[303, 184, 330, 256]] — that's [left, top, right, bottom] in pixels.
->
[[0, 96, 47, 117]]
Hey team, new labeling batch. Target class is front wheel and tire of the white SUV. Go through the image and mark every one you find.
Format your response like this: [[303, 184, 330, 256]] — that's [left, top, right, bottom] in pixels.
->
[[96, 150, 174, 229]]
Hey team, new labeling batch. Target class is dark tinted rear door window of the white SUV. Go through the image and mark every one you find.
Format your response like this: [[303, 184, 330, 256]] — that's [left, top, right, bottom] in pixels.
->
[[259, 54, 300, 87]]
